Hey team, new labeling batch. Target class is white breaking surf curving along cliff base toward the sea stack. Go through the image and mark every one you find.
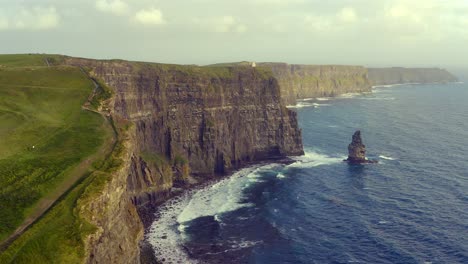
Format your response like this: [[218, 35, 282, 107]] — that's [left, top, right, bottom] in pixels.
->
[[146, 150, 344, 263]]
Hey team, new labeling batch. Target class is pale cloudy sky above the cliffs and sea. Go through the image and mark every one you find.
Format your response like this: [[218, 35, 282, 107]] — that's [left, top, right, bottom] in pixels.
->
[[0, 0, 468, 67]]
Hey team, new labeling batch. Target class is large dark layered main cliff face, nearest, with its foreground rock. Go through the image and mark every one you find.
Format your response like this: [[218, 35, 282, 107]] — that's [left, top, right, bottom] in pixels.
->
[[65, 58, 303, 263]]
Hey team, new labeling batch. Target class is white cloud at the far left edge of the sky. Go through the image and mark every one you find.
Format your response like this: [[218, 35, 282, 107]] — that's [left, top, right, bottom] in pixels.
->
[[0, 6, 60, 30]]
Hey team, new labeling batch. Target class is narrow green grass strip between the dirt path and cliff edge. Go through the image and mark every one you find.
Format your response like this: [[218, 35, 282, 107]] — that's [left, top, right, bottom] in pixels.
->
[[0, 117, 129, 264]]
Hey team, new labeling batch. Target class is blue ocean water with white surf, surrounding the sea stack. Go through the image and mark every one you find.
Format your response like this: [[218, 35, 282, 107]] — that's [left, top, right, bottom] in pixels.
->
[[148, 84, 468, 264]]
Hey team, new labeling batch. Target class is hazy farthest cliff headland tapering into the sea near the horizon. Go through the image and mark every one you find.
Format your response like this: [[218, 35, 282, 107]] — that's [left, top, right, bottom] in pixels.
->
[[369, 67, 458, 85]]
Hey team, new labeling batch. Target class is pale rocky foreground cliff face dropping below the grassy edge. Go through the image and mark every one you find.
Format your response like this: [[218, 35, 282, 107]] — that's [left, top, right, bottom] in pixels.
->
[[79, 125, 144, 264]]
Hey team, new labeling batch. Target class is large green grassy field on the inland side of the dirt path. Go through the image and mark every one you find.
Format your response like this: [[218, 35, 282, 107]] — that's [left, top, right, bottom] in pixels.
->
[[0, 65, 104, 240]]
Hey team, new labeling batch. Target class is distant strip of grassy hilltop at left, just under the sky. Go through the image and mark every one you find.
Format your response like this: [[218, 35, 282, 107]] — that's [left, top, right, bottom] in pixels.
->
[[0, 54, 62, 68]]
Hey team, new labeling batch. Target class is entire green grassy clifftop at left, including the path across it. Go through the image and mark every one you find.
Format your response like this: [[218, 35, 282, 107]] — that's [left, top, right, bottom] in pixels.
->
[[0, 55, 117, 263]]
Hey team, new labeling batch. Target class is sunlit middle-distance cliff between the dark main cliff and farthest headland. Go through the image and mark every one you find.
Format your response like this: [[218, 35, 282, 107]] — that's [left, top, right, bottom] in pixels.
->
[[257, 63, 371, 104]]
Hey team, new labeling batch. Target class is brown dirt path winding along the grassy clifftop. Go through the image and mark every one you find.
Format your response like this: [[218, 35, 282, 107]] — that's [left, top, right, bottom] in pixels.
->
[[0, 71, 117, 252]]
